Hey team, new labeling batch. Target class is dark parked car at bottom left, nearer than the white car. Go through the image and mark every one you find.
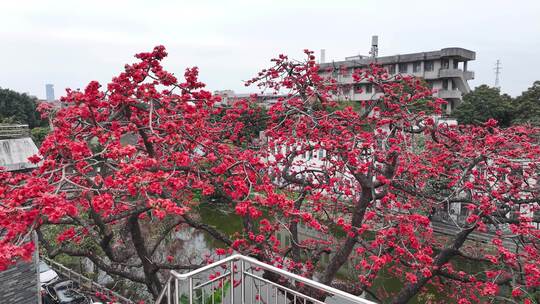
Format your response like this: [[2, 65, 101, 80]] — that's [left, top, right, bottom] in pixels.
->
[[41, 280, 93, 304]]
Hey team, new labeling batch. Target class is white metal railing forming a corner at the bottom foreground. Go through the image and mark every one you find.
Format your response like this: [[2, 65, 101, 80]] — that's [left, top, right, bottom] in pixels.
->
[[155, 254, 374, 304]]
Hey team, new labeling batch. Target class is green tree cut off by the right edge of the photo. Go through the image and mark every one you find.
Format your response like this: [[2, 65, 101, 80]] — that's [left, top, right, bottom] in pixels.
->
[[513, 80, 540, 125]]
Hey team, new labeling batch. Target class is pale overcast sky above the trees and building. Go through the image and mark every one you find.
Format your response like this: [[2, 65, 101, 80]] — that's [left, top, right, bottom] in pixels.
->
[[0, 0, 540, 98]]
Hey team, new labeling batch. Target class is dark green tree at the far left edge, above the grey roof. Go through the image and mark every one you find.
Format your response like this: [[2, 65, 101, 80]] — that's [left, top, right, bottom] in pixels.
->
[[0, 88, 47, 129]]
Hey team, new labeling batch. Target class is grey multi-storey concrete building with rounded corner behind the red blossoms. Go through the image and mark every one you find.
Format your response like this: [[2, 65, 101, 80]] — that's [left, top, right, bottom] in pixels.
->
[[320, 46, 476, 114]]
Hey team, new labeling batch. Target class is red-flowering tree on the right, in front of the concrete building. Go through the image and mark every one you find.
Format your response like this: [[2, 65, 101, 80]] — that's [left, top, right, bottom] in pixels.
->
[[242, 51, 540, 303]]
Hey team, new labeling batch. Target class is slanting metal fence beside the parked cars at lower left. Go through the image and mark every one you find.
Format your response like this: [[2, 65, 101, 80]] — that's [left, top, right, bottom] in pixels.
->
[[42, 257, 134, 304]]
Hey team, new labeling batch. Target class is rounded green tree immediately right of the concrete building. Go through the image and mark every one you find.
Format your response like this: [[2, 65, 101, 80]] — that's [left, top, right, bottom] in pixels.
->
[[454, 84, 514, 127]]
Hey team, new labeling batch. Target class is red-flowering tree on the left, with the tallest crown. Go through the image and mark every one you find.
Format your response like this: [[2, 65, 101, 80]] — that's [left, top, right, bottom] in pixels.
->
[[0, 47, 262, 296]]
